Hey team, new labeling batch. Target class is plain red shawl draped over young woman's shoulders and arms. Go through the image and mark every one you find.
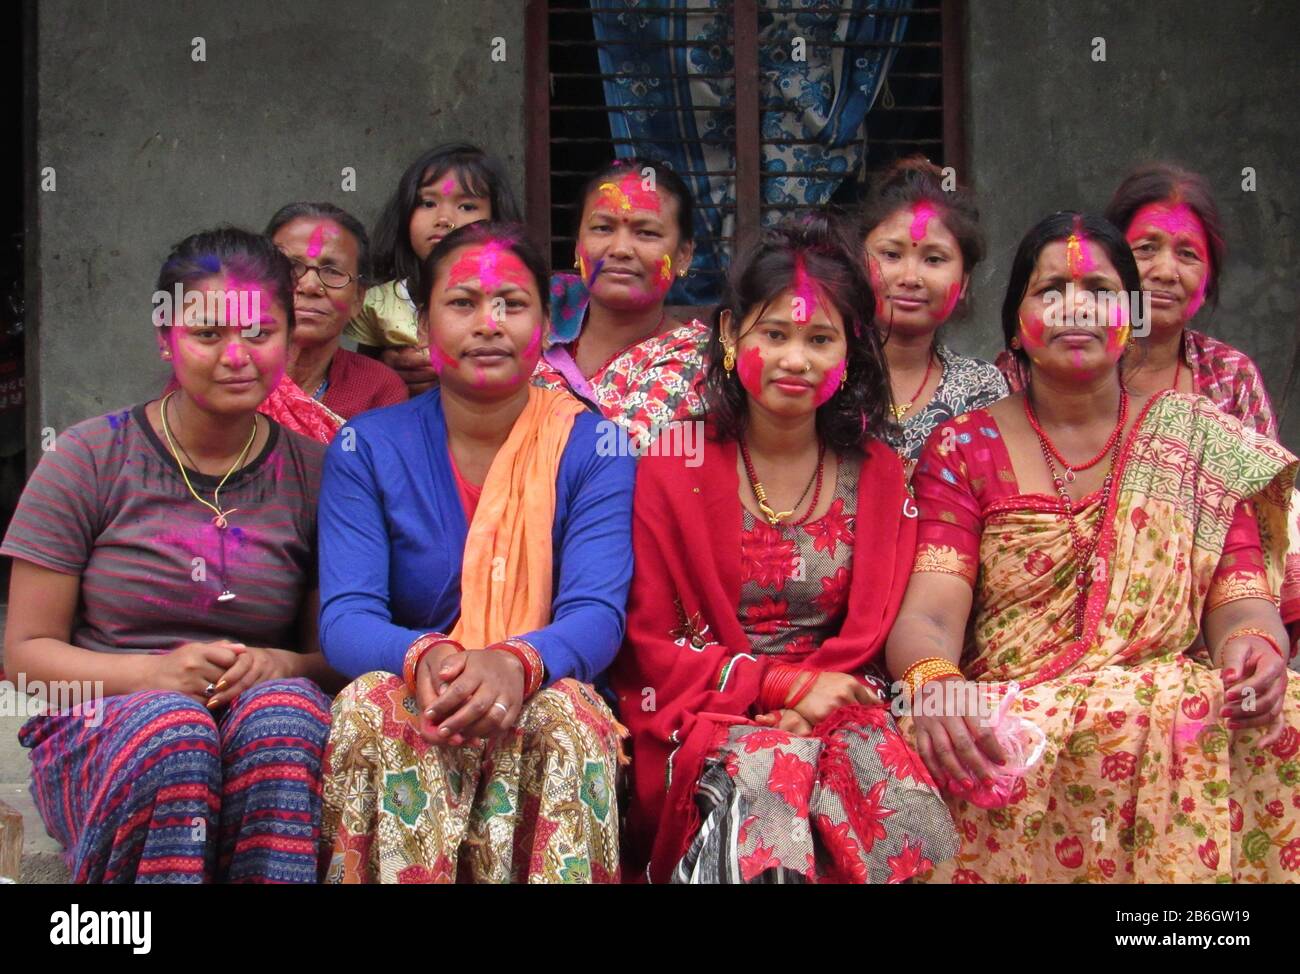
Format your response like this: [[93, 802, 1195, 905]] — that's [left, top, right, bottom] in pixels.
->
[[610, 429, 917, 882]]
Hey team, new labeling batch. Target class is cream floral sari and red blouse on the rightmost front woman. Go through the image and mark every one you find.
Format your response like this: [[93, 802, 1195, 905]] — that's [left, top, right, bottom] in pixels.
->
[[906, 393, 1300, 882]]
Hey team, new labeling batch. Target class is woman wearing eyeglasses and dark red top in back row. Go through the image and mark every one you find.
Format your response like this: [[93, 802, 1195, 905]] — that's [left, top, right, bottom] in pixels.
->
[[261, 203, 407, 443]]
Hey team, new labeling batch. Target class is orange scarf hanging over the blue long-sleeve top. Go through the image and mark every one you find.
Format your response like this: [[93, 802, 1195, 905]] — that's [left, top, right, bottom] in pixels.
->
[[450, 386, 585, 649]]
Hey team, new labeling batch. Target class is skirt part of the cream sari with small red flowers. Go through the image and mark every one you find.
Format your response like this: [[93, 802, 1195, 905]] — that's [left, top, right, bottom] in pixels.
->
[[902, 655, 1300, 883]]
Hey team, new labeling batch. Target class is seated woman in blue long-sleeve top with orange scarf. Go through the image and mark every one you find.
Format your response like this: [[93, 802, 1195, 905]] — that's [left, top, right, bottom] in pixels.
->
[[319, 224, 634, 883]]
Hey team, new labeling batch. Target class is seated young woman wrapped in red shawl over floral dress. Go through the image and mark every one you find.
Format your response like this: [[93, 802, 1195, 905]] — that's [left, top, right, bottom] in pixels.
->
[[611, 222, 957, 883]]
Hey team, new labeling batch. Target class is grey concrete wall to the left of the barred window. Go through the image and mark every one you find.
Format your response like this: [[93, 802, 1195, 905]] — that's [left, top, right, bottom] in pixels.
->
[[29, 0, 524, 444]]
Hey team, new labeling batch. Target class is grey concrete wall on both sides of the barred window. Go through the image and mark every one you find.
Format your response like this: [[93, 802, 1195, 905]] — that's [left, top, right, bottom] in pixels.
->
[[29, 0, 1300, 455]]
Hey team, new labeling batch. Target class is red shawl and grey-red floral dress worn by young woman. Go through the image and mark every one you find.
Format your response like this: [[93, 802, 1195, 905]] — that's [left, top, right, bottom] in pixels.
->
[[611, 438, 957, 883]]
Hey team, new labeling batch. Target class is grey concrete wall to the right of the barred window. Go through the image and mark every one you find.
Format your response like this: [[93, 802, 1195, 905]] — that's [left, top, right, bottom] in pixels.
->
[[950, 0, 1300, 451]]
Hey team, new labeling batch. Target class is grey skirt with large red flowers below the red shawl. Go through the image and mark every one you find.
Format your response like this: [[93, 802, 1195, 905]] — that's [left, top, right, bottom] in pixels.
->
[[672, 706, 958, 883]]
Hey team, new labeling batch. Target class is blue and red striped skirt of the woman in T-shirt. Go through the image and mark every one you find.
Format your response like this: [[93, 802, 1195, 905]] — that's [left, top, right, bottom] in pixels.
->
[[18, 679, 330, 883]]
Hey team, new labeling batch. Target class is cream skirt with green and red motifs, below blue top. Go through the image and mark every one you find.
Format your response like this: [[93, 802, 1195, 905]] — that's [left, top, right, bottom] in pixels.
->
[[321, 672, 621, 883]]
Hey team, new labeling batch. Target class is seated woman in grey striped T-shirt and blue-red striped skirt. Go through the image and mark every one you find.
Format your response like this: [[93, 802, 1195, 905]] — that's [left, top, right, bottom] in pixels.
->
[[0, 229, 337, 883]]
